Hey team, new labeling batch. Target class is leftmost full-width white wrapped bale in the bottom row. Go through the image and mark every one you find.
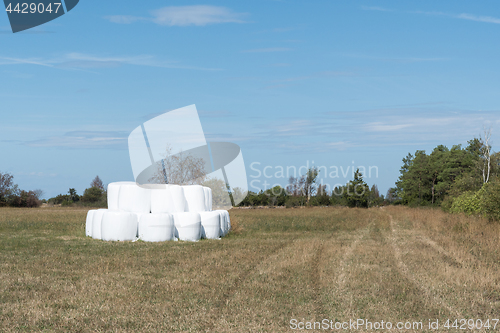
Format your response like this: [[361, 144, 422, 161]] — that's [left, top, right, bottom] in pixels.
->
[[101, 210, 137, 241]]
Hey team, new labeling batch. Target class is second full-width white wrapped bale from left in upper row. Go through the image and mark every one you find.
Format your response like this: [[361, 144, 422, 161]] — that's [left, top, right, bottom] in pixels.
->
[[150, 185, 186, 214]]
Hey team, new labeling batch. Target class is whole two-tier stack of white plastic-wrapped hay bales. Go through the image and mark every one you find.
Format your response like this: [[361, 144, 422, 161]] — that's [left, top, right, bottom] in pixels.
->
[[85, 182, 231, 242]]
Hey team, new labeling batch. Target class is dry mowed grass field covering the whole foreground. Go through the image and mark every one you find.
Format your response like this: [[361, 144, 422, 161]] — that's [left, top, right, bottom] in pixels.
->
[[0, 207, 500, 332]]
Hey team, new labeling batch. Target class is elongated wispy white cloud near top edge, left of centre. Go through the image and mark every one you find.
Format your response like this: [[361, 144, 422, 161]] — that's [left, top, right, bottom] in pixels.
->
[[105, 5, 247, 27]]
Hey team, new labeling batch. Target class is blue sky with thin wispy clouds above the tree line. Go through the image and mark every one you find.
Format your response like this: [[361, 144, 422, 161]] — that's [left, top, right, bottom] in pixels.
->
[[0, 0, 500, 198]]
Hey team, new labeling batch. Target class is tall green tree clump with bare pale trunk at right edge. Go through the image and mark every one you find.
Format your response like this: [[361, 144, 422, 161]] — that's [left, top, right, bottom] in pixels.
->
[[387, 131, 500, 220]]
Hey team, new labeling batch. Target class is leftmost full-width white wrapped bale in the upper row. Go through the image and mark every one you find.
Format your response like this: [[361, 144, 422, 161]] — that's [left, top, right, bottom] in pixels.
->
[[118, 183, 151, 213]]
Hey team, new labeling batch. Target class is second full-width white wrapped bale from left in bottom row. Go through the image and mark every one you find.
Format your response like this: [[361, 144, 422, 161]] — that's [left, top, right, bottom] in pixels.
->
[[139, 213, 175, 242]]
